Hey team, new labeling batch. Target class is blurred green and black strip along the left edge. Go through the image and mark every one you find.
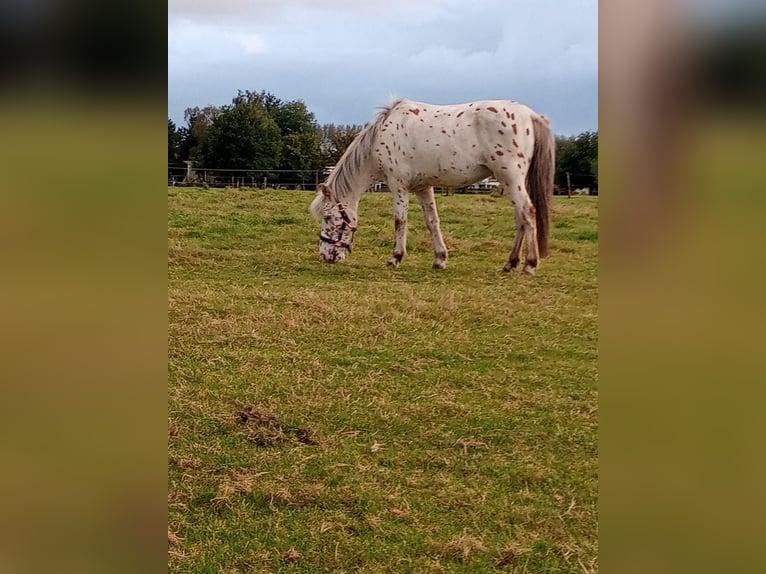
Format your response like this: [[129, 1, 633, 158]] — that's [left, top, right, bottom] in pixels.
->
[[0, 0, 167, 573]]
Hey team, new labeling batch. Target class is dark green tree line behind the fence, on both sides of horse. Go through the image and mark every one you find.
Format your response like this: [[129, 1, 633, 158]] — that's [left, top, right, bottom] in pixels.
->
[[168, 90, 598, 189]]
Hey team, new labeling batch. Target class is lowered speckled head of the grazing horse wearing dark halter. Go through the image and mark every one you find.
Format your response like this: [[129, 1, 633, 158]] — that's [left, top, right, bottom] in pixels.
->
[[310, 183, 357, 263]]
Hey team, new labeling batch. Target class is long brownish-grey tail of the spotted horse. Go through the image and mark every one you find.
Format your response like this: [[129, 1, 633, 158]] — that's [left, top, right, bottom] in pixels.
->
[[527, 114, 556, 257]]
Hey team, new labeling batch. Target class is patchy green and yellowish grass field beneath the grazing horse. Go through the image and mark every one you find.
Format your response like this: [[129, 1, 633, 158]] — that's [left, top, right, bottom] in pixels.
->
[[168, 188, 598, 573]]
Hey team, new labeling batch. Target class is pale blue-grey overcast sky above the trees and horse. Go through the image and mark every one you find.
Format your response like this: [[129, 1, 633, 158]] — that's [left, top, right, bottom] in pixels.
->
[[168, 0, 598, 135]]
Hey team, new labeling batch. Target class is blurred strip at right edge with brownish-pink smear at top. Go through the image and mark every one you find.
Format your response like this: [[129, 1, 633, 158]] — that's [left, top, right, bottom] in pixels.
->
[[599, 1, 766, 572]]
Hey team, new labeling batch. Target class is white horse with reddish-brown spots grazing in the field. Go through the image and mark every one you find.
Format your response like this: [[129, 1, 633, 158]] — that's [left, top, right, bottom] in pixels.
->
[[309, 99, 555, 275]]
